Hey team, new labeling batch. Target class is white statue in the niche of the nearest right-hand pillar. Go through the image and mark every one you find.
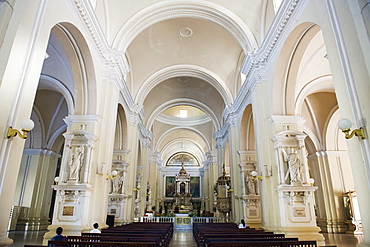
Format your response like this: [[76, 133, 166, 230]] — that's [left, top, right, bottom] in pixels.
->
[[282, 148, 302, 183]]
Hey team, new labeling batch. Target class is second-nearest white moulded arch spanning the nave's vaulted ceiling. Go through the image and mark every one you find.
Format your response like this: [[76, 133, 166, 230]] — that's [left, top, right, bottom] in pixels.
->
[[135, 64, 233, 105]]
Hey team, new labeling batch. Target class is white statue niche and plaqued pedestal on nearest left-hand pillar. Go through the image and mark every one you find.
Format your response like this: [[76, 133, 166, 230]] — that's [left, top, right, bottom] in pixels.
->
[[44, 115, 100, 242]]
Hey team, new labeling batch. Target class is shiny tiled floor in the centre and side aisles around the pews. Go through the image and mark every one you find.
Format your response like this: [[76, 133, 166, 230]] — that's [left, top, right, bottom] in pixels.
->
[[8, 229, 364, 247]]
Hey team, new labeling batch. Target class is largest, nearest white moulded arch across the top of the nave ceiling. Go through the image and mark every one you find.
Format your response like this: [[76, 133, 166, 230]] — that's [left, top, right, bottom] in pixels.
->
[[113, 0, 258, 54]]
